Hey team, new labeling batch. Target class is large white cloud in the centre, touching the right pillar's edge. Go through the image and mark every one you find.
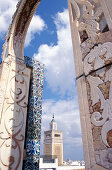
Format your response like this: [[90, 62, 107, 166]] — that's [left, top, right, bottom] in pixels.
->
[[34, 10, 75, 95]]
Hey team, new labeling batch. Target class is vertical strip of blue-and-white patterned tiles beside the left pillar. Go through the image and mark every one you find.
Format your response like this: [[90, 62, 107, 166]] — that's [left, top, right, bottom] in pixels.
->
[[25, 57, 44, 170]]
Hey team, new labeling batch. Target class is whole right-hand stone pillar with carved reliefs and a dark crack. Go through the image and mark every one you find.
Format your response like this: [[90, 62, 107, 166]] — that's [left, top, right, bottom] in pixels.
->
[[68, 0, 112, 170]]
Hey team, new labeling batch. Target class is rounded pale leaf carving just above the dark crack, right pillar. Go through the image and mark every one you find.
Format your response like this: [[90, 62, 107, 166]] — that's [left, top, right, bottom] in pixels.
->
[[84, 42, 112, 75]]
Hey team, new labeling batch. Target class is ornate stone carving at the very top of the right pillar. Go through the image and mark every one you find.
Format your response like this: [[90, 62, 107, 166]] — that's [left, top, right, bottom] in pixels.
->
[[70, 0, 103, 42]]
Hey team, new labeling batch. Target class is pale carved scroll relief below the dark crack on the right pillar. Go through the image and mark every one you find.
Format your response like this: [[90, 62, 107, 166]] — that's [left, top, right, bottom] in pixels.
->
[[87, 67, 112, 147]]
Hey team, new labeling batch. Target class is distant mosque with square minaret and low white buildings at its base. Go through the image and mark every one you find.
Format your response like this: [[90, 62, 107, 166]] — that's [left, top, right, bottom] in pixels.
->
[[39, 115, 85, 170]]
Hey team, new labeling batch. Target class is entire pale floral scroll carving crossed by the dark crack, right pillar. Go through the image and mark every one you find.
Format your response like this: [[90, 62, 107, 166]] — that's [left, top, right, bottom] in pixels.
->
[[84, 42, 112, 147]]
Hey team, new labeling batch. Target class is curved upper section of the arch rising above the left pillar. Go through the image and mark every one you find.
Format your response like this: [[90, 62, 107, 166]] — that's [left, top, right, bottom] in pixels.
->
[[2, 0, 41, 60]]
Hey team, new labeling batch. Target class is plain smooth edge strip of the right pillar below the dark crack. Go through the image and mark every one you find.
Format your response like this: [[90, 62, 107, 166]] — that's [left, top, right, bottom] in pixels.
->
[[77, 77, 95, 169]]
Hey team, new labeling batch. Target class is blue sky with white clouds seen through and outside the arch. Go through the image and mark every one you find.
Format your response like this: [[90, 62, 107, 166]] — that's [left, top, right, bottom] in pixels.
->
[[0, 0, 83, 160]]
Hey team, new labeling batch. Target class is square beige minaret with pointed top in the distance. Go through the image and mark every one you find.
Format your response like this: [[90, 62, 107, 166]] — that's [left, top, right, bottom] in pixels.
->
[[44, 115, 63, 165]]
